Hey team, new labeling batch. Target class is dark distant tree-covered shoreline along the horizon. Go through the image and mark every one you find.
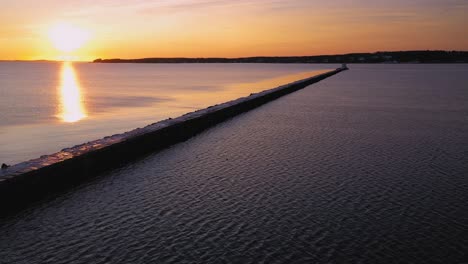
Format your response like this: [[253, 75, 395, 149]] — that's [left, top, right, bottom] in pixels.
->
[[94, 50, 468, 63]]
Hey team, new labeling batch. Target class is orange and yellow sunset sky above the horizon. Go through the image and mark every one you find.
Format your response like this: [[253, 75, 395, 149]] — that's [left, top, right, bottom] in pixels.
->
[[0, 0, 468, 60]]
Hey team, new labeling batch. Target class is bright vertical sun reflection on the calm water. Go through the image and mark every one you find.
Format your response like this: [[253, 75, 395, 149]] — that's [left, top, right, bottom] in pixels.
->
[[58, 62, 86, 123]]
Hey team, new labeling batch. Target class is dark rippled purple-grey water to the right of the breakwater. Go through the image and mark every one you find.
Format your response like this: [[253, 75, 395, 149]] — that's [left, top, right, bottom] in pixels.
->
[[0, 65, 468, 263]]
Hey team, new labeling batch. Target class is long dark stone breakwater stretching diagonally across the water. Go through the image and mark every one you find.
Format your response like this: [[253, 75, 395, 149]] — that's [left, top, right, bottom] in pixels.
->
[[0, 67, 347, 212]]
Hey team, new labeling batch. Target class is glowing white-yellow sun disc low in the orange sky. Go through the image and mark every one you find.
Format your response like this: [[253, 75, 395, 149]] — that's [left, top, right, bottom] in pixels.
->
[[49, 23, 89, 52]]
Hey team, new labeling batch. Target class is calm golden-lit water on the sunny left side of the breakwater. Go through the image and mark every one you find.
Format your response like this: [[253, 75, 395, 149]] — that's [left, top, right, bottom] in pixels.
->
[[0, 62, 330, 164]]
